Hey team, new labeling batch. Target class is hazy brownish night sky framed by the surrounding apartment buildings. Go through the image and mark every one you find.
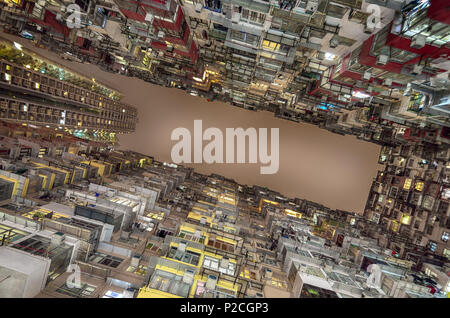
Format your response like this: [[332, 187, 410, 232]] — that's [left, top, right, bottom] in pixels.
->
[[5, 36, 380, 213]]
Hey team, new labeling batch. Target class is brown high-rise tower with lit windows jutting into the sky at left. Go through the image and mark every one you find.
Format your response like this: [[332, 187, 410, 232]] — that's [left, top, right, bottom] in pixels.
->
[[0, 36, 137, 141]]
